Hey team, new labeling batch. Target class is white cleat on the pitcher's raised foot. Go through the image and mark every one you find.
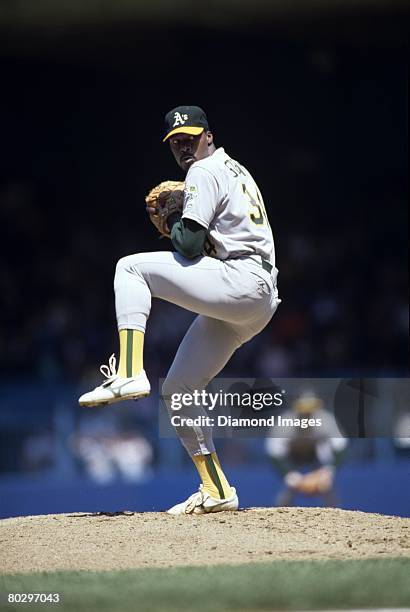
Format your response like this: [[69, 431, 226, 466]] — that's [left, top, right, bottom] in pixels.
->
[[78, 355, 151, 406]]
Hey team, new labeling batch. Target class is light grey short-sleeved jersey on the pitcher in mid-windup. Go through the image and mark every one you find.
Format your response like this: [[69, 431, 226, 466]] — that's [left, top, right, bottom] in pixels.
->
[[182, 147, 275, 266]]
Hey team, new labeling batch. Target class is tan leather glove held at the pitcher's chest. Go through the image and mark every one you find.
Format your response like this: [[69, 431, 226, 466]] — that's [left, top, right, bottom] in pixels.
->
[[145, 181, 185, 238]]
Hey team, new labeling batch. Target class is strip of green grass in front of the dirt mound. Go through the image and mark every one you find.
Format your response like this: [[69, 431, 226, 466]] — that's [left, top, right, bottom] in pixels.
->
[[0, 558, 410, 612]]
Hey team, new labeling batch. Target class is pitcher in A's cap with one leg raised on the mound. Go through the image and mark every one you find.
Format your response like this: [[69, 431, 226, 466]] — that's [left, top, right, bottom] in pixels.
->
[[79, 106, 280, 514]]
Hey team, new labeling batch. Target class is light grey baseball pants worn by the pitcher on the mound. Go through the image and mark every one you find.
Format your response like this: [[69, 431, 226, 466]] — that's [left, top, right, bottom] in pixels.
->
[[114, 251, 281, 455]]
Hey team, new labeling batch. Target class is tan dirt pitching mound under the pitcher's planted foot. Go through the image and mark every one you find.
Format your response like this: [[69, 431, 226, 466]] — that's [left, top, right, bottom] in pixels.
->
[[0, 508, 410, 574]]
